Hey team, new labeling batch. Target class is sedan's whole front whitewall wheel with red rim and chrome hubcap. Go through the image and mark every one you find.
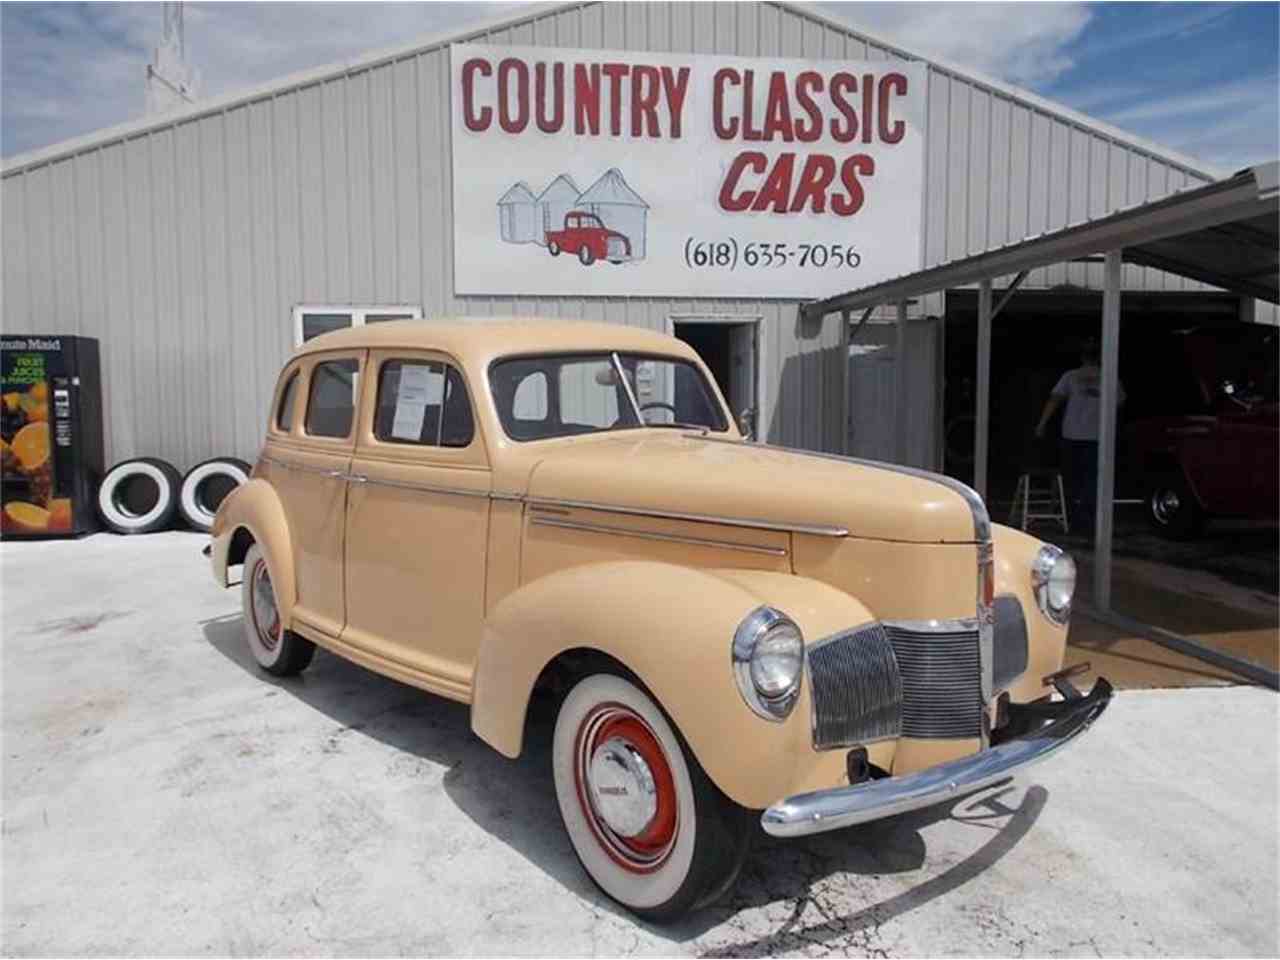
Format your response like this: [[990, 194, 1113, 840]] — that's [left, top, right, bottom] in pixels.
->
[[552, 673, 754, 920]]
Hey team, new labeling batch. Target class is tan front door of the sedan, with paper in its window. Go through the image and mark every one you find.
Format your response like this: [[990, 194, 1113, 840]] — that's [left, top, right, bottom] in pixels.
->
[[343, 349, 490, 700]]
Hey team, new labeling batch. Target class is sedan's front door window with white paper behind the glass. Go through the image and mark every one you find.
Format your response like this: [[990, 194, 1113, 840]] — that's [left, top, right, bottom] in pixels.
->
[[374, 360, 475, 447]]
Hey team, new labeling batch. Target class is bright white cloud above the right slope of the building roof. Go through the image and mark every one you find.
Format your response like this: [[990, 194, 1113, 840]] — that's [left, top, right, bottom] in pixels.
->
[[822, 3, 1091, 87]]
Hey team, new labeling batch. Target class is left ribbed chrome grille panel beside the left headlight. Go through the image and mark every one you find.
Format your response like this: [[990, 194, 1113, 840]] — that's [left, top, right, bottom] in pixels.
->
[[808, 623, 902, 750]]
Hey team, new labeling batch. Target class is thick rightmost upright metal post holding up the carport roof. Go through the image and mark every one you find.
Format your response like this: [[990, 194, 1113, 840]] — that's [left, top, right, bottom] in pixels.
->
[[1093, 250, 1121, 612]]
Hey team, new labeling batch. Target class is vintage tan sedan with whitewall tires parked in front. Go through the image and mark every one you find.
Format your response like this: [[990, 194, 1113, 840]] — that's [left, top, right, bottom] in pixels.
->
[[206, 321, 1111, 919]]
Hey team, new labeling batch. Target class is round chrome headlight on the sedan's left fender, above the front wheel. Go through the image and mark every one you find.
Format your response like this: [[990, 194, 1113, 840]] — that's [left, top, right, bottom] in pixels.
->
[[732, 607, 804, 721]]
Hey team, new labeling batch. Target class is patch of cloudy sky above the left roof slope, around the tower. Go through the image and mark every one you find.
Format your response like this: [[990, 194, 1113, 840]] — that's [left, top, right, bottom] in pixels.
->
[[0, 3, 518, 156]]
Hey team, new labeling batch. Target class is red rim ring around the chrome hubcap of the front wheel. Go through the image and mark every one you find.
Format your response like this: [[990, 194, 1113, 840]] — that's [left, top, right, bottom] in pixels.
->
[[573, 703, 678, 873]]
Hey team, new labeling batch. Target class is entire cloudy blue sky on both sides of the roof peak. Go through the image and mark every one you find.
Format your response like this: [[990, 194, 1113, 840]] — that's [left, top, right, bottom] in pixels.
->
[[0, 3, 1280, 172]]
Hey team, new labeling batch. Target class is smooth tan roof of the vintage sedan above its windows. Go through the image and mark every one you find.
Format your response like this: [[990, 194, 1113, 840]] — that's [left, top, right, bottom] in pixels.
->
[[293, 317, 696, 366]]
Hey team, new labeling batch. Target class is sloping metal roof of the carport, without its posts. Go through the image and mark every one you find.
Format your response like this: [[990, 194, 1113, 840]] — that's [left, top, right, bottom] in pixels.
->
[[803, 161, 1280, 317]]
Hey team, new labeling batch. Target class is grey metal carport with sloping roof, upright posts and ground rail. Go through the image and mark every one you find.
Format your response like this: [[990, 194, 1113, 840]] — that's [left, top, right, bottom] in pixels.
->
[[801, 161, 1280, 689]]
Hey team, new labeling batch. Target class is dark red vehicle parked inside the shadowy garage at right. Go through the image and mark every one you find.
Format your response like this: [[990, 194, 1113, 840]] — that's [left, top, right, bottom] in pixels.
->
[[1123, 328, 1280, 539]]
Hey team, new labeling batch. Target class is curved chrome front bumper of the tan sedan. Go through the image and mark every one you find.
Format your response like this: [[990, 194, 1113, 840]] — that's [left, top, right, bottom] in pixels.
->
[[760, 678, 1111, 837]]
